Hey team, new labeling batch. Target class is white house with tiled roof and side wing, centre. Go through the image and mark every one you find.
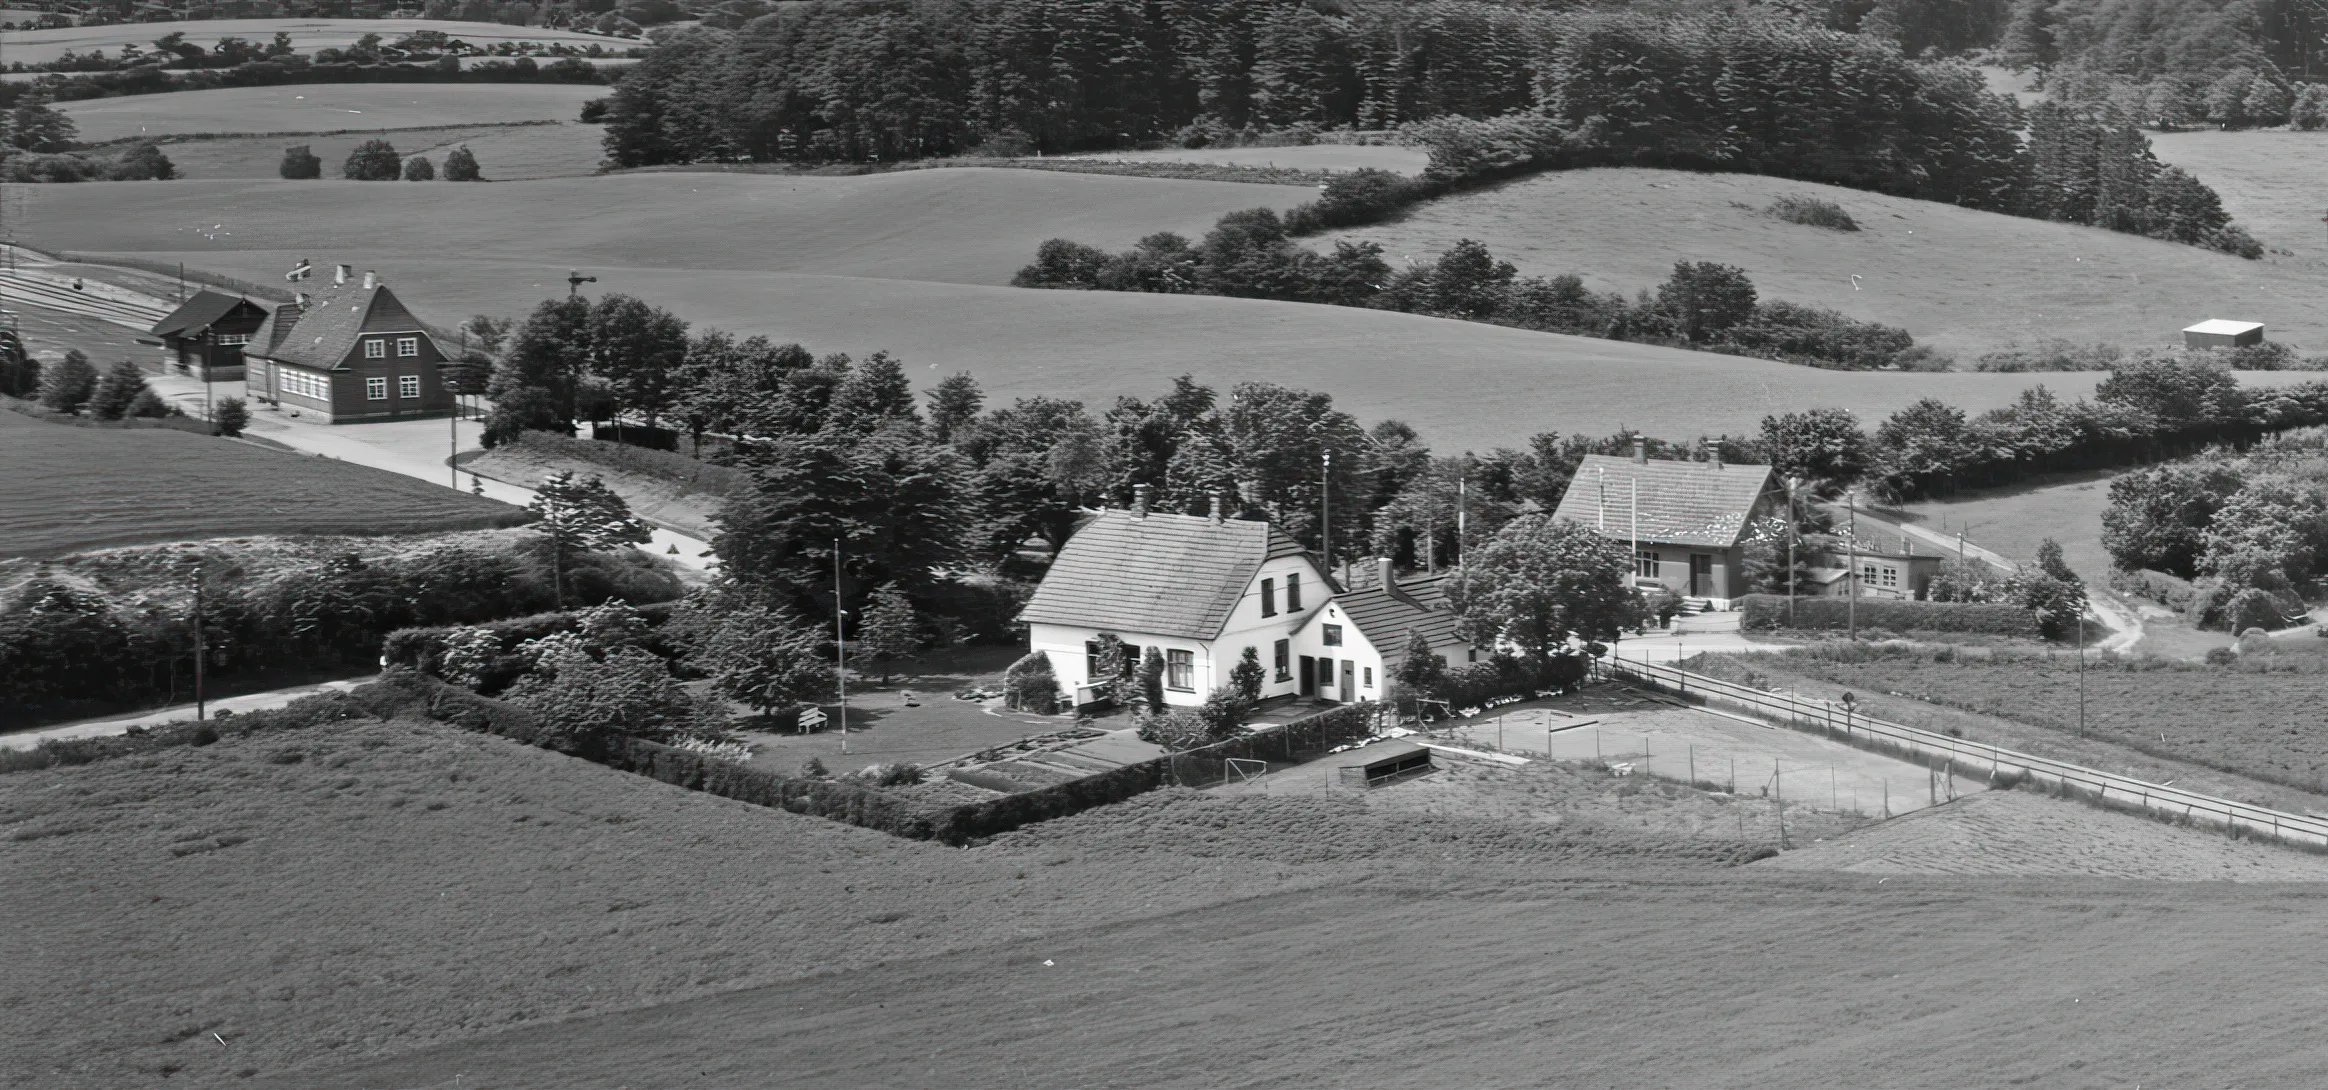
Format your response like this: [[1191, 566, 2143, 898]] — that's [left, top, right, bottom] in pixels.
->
[[1020, 487, 1406, 706]]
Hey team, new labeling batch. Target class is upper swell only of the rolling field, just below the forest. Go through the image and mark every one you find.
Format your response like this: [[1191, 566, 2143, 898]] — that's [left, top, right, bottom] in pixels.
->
[[19, 170, 1315, 287]]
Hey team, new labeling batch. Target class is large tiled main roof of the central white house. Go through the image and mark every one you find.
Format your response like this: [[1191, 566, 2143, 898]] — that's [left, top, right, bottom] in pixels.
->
[[1020, 510, 1301, 640]]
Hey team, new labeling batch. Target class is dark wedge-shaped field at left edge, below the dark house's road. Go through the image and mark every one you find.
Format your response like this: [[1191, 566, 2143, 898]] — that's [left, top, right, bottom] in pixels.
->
[[0, 410, 526, 557]]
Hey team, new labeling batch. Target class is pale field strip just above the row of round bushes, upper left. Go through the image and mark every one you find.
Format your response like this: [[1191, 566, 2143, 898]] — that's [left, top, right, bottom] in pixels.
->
[[58, 83, 605, 142]]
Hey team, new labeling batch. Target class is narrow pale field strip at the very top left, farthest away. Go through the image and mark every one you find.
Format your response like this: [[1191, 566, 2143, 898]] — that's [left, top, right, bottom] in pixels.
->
[[7, 19, 619, 66]]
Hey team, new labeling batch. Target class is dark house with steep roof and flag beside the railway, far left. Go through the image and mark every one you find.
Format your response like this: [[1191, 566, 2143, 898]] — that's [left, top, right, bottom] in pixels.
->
[[244, 266, 454, 424]]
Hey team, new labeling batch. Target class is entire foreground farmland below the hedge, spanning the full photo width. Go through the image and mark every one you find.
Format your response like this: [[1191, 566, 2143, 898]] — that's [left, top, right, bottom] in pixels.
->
[[13, 720, 2328, 1090]]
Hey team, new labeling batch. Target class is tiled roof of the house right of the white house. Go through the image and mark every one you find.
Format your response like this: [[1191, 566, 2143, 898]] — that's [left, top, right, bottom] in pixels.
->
[[1553, 454, 1772, 547]]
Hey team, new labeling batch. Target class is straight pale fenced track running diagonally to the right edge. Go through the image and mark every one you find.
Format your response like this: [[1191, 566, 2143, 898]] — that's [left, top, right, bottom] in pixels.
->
[[1606, 654, 2328, 850]]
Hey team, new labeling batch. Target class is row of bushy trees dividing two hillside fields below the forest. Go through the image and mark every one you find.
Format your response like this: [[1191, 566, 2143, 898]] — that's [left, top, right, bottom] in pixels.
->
[[1013, 215, 1949, 370]]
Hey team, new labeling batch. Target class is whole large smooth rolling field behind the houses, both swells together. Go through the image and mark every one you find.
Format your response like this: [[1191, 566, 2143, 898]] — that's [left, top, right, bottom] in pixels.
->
[[23, 160, 2318, 447]]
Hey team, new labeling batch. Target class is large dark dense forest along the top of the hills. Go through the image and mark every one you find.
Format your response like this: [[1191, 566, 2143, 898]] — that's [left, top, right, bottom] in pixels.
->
[[603, 0, 2244, 252]]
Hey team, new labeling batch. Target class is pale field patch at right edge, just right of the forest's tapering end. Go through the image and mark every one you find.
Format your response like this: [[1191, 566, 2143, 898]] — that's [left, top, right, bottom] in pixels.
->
[[2149, 130, 2328, 266]]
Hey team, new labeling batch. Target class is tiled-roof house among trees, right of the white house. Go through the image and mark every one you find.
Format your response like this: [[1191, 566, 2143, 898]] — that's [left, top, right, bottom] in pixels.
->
[[1553, 438, 1786, 610]]
